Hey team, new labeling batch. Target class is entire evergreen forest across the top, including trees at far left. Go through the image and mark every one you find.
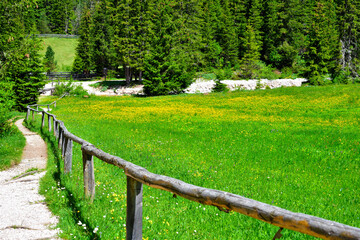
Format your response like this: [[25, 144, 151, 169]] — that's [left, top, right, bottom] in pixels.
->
[[0, 0, 360, 119]]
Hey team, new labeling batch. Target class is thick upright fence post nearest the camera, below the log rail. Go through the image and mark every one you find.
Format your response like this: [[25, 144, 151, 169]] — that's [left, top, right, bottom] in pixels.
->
[[126, 176, 143, 240]]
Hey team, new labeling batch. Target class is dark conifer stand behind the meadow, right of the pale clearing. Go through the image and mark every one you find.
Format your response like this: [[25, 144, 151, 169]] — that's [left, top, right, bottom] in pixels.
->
[[69, 0, 360, 94]]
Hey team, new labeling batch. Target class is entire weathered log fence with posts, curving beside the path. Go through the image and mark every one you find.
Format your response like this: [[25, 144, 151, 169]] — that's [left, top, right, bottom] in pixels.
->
[[26, 101, 360, 240]]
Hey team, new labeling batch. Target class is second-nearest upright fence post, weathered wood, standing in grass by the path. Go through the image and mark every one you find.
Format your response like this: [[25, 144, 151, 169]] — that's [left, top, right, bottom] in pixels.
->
[[81, 149, 95, 202]]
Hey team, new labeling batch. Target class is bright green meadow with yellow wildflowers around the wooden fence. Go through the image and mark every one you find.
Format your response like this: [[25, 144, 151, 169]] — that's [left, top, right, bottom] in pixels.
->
[[31, 85, 360, 239]]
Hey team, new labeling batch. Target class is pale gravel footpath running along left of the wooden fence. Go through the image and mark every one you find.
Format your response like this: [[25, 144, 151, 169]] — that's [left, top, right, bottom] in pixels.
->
[[0, 119, 59, 239]]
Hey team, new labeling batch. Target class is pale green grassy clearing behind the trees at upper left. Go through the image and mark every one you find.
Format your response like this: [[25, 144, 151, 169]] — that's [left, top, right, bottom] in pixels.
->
[[40, 38, 78, 72]]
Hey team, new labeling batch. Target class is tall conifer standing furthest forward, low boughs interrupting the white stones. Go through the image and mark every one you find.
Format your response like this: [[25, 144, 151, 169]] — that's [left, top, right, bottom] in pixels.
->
[[143, 0, 197, 95]]
